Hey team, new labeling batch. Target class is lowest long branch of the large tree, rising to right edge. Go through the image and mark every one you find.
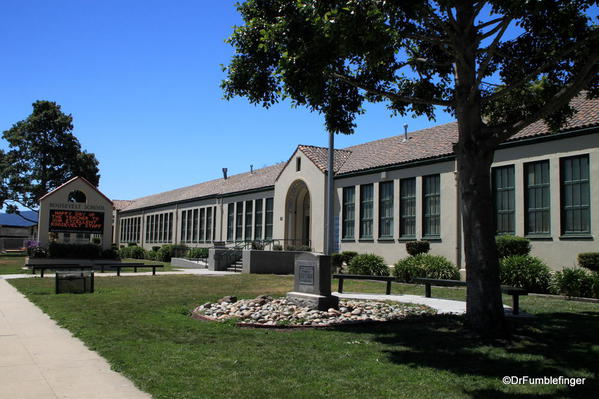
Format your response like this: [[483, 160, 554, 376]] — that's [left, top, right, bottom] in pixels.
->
[[495, 52, 599, 141]]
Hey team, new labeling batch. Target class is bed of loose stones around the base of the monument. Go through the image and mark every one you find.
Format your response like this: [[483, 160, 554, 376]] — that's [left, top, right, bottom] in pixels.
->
[[192, 295, 436, 328]]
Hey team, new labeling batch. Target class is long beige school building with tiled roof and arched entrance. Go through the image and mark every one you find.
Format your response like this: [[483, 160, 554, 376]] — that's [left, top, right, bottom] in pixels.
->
[[116, 96, 599, 269]]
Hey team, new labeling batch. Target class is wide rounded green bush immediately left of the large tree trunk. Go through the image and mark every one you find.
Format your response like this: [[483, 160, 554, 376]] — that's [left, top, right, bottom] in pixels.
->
[[393, 254, 460, 283]]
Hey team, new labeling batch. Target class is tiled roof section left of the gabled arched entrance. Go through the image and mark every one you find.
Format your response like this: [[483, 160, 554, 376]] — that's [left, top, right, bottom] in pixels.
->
[[123, 163, 284, 211]]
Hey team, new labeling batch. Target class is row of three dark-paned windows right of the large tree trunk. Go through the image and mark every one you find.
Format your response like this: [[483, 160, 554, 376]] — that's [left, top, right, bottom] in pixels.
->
[[492, 155, 591, 235]]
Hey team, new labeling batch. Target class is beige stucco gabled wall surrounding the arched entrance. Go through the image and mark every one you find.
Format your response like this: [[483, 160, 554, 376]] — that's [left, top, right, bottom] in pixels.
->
[[273, 149, 326, 252]]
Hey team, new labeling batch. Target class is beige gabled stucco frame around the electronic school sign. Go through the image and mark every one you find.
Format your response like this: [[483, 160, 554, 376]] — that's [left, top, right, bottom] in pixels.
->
[[38, 179, 113, 249]]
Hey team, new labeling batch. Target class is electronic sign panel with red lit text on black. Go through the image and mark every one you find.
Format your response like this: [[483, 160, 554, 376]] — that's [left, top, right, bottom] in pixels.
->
[[48, 209, 104, 234]]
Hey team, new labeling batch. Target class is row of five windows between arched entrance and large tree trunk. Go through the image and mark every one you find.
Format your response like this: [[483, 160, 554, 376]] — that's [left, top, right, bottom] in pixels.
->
[[341, 174, 441, 240]]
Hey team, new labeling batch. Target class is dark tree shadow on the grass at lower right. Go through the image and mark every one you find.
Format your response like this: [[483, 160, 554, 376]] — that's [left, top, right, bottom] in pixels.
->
[[332, 312, 599, 399]]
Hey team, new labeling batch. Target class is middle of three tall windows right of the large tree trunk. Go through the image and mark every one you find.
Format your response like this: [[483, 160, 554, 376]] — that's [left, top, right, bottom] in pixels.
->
[[524, 161, 551, 234]]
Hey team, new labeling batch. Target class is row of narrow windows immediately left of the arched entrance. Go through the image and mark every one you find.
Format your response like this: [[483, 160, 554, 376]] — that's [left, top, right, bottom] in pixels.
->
[[227, 198, 273, 241]]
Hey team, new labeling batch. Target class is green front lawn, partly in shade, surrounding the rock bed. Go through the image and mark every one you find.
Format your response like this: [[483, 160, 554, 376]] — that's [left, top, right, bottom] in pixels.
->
[[10, 275, 599, 399]]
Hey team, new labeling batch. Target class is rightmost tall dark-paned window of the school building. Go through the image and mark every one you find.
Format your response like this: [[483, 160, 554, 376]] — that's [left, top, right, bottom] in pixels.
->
[[560, 155, 591, 235]]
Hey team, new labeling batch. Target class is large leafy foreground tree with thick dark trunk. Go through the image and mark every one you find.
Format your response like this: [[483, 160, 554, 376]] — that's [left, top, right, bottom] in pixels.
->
[[222, 0, 599, 334]]
